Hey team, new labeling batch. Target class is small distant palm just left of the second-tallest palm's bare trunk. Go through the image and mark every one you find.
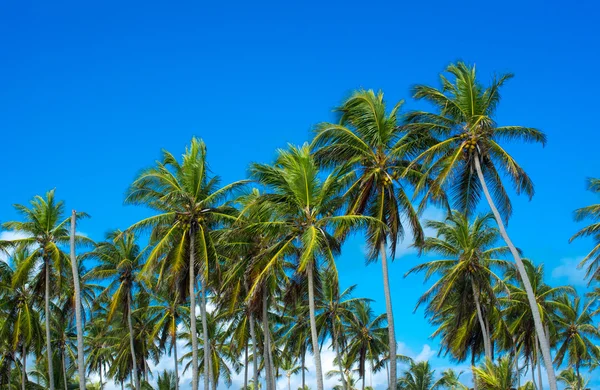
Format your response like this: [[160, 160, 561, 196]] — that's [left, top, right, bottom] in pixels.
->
[[345, 300, 388, 390]]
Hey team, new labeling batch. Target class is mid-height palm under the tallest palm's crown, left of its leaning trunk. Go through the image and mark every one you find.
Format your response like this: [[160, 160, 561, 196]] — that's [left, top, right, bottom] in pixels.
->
[[407, 211, 508, 359]]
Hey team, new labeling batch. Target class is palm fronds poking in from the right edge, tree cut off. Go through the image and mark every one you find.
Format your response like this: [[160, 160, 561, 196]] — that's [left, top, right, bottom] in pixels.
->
[[569, 178, 600, 283]]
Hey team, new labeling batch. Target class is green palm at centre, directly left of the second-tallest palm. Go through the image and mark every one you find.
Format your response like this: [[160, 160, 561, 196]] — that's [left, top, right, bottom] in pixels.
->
[[249, 144, 376, 390]]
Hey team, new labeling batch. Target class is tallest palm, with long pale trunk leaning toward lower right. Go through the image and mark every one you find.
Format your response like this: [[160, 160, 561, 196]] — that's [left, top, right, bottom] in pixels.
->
[[406, 62, 556, 390]]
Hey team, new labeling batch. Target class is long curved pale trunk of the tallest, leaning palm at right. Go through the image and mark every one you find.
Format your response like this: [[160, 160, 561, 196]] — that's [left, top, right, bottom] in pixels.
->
[[474, 153, 558, 390]]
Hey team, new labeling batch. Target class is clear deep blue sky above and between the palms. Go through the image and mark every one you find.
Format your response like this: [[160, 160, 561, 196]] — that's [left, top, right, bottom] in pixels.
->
[[0, 1, 600, 388]]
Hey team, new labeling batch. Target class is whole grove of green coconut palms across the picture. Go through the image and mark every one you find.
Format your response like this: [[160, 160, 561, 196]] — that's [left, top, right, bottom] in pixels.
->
[[0, 62, 600, 390]]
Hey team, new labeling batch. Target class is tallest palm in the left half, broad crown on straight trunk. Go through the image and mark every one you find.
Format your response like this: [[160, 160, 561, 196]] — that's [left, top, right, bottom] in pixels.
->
[[126, 138, 244, 390]]
